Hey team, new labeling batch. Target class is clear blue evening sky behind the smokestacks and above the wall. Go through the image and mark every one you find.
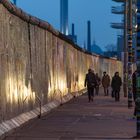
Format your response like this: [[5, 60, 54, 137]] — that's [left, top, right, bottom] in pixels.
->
[[13, 0, 122, 49]]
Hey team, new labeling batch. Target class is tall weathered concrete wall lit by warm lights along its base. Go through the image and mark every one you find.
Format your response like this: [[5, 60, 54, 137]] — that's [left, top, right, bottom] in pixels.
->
[[0, 0, 122, 122]]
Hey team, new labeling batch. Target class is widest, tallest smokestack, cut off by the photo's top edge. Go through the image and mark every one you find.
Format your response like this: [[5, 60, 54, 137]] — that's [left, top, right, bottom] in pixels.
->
[[60, 0, 69, 35]]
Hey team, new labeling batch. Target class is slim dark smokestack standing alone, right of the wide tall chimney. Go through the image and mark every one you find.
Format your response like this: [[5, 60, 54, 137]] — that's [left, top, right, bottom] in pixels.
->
[[87, 21, 91, 52]]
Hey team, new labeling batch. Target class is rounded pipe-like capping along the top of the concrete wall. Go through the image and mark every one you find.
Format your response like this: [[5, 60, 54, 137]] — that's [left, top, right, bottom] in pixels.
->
[[0, 0, 120, 60]]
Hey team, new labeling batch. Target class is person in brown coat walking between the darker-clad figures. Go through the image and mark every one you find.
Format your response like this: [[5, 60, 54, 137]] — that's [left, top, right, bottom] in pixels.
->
[[102, 72, 110, 96]]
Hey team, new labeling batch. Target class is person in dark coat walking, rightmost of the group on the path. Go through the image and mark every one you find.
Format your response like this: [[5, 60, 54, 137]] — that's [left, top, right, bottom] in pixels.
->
[[111, 72, 122, 101]]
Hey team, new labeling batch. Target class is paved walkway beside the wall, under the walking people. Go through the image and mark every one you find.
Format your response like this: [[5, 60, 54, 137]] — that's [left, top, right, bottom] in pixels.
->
[[5, 89, 136, 140]]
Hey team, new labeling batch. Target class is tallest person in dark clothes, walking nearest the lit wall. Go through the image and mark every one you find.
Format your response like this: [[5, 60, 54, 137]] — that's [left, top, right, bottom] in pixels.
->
[[85, 69, 96, 102]]
